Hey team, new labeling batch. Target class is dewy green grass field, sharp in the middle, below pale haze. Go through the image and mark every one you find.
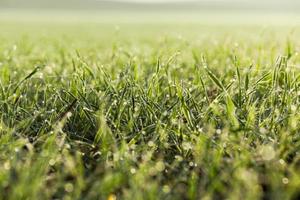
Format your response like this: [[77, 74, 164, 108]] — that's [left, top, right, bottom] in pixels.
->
[[0, 11, 300, 200]]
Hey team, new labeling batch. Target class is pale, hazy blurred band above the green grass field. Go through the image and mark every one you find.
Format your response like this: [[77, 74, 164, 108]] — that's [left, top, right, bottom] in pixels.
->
[[0, 0, 300, 25]]
